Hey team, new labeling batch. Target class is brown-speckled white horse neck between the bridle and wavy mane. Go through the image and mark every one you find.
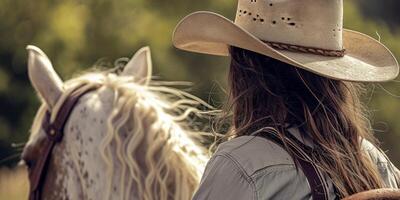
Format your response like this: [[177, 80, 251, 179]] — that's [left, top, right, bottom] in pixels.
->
[[59, 88, 118, 199]]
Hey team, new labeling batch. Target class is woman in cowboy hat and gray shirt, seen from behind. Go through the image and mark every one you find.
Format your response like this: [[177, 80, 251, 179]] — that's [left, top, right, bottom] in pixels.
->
[[174, 0, 400, 199]]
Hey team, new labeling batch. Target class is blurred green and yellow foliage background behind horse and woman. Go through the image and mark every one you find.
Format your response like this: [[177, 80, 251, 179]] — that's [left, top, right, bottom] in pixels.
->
[[0, 0, 400, 175]]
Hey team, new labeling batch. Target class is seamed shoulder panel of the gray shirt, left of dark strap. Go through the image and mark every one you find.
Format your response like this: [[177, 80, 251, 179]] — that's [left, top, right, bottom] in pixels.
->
[[214, 136, 294, 176]]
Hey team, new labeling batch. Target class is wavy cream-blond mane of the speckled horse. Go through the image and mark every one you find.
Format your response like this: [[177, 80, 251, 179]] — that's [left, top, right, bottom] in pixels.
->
[[32, 72, 211, 200]]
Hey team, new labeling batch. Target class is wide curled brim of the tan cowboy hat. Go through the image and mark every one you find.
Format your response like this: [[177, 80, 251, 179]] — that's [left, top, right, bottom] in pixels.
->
[[173, 11, 399, 82]]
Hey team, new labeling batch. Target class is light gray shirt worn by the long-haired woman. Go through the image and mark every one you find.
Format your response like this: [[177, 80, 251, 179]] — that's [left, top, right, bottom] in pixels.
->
[[193, 129, 398, 200]]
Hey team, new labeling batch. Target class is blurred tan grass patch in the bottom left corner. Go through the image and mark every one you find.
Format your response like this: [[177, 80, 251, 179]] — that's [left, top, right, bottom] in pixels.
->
[[0, 167, 29, 200]]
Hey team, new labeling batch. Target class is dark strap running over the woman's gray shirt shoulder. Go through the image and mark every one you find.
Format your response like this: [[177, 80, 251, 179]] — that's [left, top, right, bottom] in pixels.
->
[[257, 132, 328, 200]]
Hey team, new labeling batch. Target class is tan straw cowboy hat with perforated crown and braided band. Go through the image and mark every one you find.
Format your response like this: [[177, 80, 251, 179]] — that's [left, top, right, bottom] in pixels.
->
[[173, 0, 399, 82]]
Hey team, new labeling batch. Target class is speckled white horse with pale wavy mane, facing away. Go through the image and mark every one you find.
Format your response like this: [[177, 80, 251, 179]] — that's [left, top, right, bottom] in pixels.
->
[[22, 46, 210, 200]]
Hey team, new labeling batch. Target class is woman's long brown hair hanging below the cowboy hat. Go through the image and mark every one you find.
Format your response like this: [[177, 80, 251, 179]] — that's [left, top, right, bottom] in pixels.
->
[[227, 47, 383, 197]]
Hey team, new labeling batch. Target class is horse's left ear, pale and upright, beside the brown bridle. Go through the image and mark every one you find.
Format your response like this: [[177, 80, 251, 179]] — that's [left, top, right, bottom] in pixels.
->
[[26, 45, 63, 109]]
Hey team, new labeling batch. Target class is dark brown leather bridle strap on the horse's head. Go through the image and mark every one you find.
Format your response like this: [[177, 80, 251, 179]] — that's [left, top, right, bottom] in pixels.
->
[[29, 84, 100, 200]]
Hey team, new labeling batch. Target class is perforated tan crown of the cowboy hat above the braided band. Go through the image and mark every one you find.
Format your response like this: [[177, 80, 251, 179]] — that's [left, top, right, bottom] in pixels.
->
[[235, 0, 343, 50]]
